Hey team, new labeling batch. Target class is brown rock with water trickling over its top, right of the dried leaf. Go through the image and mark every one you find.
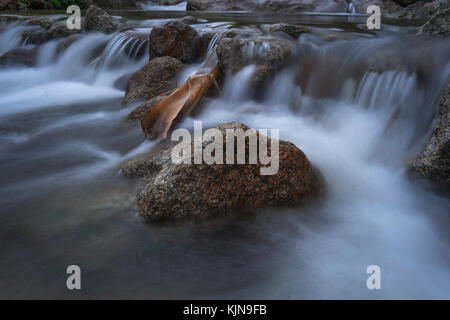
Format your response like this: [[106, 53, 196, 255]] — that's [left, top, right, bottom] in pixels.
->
[[217, 37, 296, 89]]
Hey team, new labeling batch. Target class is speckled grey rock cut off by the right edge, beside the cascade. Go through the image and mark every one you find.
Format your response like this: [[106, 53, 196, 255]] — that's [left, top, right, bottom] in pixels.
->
[[408, 84, 450, 190]]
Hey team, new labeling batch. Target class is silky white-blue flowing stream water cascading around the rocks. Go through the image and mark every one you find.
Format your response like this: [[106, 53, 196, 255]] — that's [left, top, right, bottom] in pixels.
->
[[0, 10, 450, 299]]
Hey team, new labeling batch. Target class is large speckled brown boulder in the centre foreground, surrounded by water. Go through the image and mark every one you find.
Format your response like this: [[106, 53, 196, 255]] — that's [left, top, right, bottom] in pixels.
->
[[122, 122, 323, 219]]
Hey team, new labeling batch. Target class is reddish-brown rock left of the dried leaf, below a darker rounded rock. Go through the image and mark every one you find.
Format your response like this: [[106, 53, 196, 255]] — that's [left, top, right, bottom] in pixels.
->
[[122, 57, 183, 105]]
